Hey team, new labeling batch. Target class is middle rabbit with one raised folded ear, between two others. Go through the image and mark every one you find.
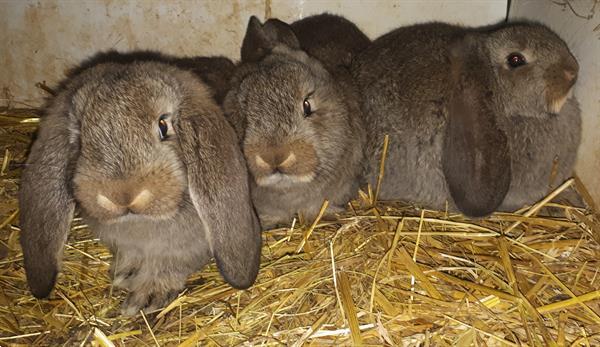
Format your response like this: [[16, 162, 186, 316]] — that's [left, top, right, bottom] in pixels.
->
[[223, 17, 366, 228]]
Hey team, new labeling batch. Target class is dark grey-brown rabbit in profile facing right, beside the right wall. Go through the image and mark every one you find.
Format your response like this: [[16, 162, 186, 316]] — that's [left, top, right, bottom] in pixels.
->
[[351, 22, 581, 217]]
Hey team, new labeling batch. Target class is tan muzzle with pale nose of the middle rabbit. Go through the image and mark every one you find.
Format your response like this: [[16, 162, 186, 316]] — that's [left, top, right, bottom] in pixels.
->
[[244, 140, 318, 186]]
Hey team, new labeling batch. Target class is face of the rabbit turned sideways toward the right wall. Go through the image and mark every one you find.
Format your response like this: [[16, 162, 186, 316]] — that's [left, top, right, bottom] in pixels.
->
[[483, 25, 579, 117]]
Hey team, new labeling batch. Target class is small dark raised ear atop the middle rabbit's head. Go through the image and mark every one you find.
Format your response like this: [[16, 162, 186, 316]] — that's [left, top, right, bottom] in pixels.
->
[[241, 16, 300, 62]]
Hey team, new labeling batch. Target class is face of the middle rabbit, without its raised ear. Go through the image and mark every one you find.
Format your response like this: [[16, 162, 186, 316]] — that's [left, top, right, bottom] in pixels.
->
[[238, 48, 352, 188]]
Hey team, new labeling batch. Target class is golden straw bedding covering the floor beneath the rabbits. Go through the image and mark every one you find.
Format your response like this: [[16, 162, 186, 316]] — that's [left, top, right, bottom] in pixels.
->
[[0, 110, 600, 346]]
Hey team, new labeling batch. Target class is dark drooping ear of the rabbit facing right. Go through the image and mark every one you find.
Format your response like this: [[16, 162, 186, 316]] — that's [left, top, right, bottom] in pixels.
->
[[442, 42, 511, 217]]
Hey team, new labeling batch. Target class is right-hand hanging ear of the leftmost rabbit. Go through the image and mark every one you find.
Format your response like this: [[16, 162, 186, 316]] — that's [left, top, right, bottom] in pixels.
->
[[174, 94, 261, 289]]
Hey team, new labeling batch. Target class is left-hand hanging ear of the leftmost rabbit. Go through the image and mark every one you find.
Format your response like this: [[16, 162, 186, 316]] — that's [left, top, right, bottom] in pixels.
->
[[19, 94, 75, 298]]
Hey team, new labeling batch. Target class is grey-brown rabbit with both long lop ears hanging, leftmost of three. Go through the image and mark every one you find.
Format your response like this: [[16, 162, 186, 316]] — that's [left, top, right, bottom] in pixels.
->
[[19, 61, 261, 315]]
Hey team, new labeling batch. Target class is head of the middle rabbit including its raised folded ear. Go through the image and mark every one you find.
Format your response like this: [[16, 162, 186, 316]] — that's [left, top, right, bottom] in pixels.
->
[[225, 17, 362, 193]]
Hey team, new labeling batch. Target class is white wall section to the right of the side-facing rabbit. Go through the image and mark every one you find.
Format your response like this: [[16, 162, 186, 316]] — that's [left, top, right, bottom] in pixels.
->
[[510, 0, 600, 205]]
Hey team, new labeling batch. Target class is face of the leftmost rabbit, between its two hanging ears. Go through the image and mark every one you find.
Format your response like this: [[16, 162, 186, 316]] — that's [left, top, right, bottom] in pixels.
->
[[73, 76, 186, 222]]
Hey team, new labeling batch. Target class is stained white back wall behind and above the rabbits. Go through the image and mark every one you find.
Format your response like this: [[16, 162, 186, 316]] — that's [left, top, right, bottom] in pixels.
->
[[0, 0, 507, 106]]
